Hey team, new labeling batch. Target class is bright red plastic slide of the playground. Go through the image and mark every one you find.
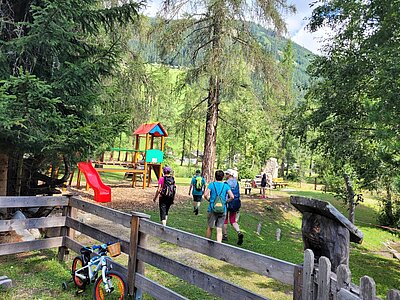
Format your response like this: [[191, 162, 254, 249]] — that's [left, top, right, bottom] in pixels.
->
[[78, 162, 111, 202]]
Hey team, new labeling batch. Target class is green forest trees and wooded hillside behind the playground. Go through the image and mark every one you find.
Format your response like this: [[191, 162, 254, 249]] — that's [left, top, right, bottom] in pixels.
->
[[0, 0, 400, 229]]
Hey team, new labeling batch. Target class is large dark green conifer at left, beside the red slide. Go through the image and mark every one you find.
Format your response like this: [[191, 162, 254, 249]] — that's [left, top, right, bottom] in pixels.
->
[[0, 0, 139, 195]]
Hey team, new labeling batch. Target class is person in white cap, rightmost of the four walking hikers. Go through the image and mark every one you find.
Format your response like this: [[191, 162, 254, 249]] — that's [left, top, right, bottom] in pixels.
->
[[222, 169, 243, 246]]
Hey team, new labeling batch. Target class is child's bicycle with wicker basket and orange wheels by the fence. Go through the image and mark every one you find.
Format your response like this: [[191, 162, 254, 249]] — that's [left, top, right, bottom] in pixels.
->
[[63, 243, 128, 300]]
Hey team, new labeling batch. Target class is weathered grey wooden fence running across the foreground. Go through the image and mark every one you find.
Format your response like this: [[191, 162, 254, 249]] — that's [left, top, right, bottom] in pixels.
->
[[0, 196, 400, 300]]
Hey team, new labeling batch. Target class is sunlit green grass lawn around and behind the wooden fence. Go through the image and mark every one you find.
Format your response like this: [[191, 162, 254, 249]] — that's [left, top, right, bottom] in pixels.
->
[[0, 179, 400, 300]]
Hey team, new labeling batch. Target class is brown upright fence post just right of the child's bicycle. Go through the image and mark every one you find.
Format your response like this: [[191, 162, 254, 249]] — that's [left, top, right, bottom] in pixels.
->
[[128, 212, 150, 300]]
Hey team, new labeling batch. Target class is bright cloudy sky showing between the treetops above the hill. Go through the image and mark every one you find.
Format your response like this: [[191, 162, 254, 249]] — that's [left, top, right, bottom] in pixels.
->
[[145, 0, 327, 54]]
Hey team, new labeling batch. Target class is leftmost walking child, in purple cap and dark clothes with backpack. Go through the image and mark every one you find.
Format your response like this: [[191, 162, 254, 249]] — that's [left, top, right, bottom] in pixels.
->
[[153, 167, 176, 226]]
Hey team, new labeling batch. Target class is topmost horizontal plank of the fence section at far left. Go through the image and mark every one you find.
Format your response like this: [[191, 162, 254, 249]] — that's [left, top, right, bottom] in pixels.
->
[[0, 196, 69, 208]]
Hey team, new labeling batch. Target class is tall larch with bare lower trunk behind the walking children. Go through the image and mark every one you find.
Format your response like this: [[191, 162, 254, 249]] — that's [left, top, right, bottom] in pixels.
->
[[155, 0, 294, 181]]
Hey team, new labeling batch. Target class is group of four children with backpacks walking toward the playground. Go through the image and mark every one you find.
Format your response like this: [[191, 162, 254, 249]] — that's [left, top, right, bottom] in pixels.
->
[[153, 167, 243, 245]]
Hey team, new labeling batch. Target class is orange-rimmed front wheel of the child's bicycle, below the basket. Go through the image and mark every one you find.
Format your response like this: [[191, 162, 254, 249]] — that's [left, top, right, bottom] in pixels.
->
[[93, 271, 128, 300]]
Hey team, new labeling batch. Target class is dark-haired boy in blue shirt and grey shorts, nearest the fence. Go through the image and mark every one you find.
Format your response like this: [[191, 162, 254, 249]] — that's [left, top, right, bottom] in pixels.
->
[[204, 170, 234, 243]]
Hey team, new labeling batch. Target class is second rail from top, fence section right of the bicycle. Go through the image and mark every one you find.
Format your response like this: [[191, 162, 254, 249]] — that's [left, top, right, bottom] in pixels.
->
[[138, 246, 268, 300]]
